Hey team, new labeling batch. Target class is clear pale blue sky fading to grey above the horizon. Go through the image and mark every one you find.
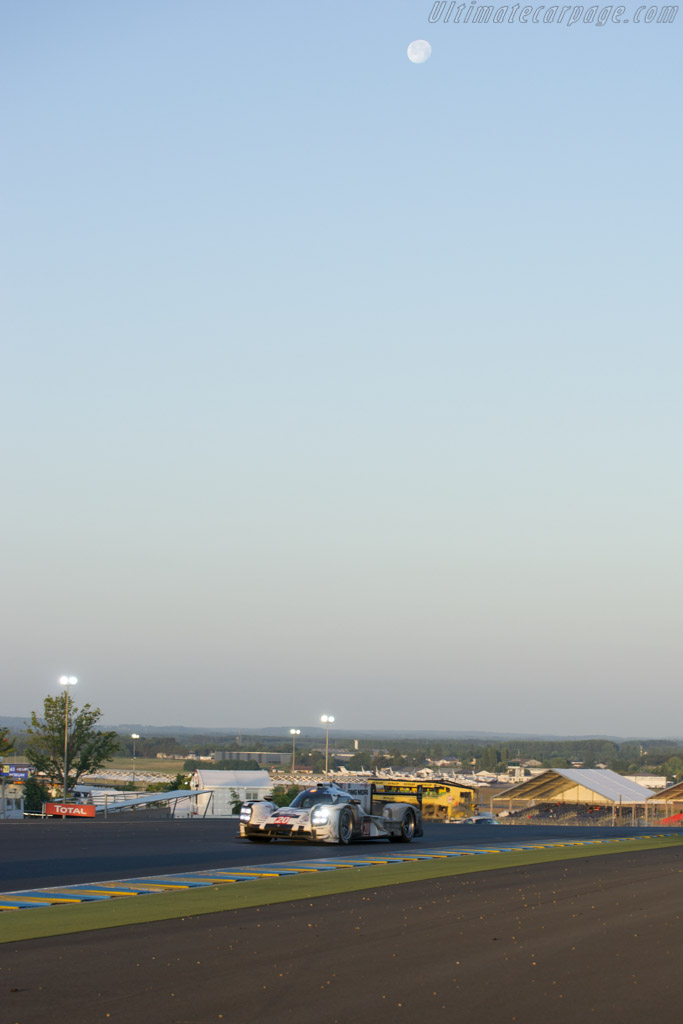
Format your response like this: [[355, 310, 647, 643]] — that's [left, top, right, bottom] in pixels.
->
[[0, 0, 683, 735]]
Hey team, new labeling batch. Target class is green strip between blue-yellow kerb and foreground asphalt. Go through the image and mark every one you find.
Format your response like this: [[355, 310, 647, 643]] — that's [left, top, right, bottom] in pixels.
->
[[0, 837, 683, 943]]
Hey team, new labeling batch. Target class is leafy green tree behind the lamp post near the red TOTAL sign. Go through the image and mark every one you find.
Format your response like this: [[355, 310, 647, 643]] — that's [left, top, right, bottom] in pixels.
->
[[26, 692, 120, 788]]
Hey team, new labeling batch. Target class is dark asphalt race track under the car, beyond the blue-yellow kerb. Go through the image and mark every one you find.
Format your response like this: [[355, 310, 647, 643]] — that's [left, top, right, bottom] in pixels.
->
[[0, 818, 660, 892]]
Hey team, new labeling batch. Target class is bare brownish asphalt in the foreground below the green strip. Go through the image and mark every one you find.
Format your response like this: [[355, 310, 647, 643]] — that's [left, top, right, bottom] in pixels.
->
[[0, 846, 683, 1024]]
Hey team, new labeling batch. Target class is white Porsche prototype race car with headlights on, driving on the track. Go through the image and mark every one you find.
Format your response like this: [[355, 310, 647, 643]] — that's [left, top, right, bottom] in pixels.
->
[[240, 782, 423, 845]]
